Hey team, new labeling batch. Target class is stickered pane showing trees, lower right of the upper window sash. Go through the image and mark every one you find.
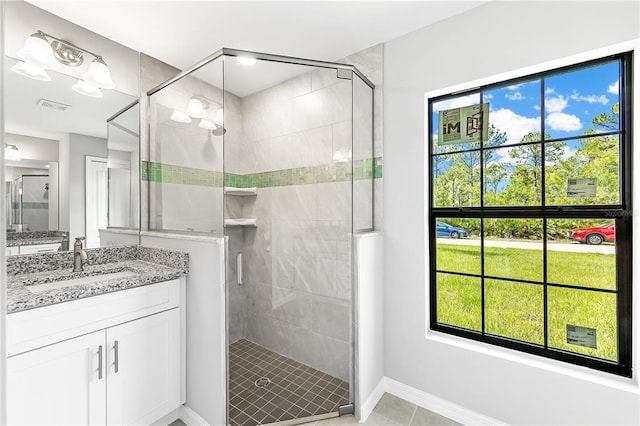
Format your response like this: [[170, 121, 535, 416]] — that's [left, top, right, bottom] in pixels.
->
[[545, 136, 620, 206]]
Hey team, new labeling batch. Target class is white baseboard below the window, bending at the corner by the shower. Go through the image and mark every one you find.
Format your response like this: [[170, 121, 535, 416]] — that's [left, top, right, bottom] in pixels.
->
[[359, 377, 508, 426]]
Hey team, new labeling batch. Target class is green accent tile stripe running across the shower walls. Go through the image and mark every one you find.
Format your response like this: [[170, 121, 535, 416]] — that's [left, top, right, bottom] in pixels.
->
[[141, 157, 382, 188]]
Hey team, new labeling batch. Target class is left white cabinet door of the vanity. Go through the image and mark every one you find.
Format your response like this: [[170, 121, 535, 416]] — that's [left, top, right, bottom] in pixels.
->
[[7, 331, 106, 425]]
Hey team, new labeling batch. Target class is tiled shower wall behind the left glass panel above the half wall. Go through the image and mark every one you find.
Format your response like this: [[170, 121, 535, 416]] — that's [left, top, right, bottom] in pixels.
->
[[143, 60, 234, 235]]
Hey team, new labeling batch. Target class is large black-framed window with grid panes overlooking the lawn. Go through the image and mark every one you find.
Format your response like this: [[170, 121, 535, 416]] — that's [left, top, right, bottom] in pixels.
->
[[428, 54, 632, 377]]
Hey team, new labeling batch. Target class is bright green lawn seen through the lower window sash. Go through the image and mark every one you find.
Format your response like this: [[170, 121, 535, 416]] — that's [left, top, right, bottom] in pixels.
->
[[436, 243, 617, 360]]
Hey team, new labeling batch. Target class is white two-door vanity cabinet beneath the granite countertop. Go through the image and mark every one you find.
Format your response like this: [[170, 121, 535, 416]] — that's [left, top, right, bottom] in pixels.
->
[[7, 279, 185, 425]]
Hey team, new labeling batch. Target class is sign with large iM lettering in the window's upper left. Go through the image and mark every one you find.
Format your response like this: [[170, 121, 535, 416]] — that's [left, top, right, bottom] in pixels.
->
[[438, 103, 489, 145]]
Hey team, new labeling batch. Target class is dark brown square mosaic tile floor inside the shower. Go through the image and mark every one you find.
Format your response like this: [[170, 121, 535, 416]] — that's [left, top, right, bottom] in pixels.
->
[[229, 339, 349, 426]]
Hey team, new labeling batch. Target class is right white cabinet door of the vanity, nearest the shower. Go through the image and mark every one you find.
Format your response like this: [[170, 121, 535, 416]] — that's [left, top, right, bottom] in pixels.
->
[[107, 308, 180, 425]]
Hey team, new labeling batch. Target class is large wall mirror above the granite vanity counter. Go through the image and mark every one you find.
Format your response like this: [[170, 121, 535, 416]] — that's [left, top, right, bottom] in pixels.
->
[[3, 57, 140, 250]]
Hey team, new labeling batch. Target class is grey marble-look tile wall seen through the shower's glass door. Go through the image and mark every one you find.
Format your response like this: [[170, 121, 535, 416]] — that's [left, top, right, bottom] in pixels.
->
[[225, 50, 381, 380]]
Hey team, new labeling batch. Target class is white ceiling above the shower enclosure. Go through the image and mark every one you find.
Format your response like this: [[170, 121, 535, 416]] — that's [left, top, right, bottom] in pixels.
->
[[23, 0, 487, 69]]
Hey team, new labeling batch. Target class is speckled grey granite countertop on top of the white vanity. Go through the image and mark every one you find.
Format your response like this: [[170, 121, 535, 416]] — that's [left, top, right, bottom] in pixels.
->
[[7, 246, 189, 314]]
